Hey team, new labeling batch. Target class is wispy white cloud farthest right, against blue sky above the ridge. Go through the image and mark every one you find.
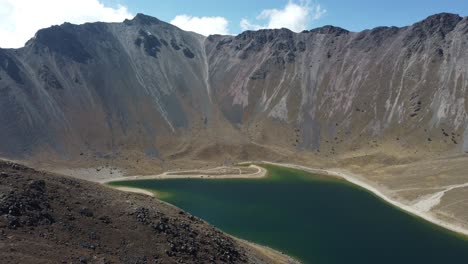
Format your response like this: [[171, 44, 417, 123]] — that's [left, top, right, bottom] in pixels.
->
[[240, 0, 327, 32]]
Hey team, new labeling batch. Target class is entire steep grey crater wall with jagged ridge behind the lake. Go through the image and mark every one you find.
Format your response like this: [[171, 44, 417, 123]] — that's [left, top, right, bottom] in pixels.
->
[[0, 13, 468, 165]]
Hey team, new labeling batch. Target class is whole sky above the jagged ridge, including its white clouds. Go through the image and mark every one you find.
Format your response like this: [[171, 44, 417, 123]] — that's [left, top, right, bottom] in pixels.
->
[[0, 0, 468, 48]]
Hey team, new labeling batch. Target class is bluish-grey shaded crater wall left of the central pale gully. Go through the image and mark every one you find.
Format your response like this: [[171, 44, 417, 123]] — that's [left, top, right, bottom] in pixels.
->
[[0, 15, 217, 161]]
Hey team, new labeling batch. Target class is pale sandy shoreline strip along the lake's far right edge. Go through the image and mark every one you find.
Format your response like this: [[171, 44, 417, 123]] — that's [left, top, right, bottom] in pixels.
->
[[258, 161, 468, 237]]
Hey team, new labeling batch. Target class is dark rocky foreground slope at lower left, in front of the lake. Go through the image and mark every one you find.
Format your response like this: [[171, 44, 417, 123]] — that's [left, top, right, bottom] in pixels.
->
[[0, 161, 285, 263]]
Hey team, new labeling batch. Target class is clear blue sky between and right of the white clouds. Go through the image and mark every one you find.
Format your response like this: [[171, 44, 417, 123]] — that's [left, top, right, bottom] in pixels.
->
[[118, 0, 468, 34]]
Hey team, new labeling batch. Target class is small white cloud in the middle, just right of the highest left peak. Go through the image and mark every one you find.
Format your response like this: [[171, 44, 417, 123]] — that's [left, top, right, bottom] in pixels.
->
[[170, 15, 229, 36]]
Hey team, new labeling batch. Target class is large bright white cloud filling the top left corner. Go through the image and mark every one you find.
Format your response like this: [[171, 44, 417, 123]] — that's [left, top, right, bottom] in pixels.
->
[[0, 0, 132, 48]]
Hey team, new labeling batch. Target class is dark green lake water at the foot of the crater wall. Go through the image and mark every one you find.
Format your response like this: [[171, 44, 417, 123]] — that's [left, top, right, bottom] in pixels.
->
[[111, 165, 468, 264]]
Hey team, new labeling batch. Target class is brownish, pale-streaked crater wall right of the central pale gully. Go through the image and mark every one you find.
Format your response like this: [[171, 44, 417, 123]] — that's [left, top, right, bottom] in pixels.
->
[[207, 14, 468, 154]]
